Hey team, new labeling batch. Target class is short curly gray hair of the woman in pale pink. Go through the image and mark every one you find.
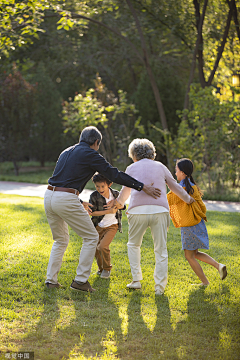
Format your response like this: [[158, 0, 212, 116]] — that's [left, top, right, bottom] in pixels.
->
[[128, 139, 156, 161]]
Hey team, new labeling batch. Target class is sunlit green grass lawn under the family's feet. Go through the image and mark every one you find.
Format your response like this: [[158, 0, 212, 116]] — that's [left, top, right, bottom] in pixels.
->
[[0, 195, 240, 360]]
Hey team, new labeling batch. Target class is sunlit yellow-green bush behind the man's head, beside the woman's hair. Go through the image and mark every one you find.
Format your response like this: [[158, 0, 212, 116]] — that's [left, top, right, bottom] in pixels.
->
[[63, 75, 144, 168]]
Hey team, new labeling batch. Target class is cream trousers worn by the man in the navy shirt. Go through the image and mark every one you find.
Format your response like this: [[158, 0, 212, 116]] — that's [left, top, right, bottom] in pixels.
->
[[44, 190, 99, 284]]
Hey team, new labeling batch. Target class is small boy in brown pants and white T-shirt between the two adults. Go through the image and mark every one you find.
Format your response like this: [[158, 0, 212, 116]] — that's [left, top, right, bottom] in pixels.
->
[[89, 173, 126, 279]]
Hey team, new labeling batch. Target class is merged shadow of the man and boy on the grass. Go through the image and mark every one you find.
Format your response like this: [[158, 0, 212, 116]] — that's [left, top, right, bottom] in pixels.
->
[[18, 277, 124, 360]]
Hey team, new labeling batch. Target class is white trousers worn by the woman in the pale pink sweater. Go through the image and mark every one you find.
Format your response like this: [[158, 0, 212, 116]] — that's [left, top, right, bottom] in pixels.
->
[[127, 212, 170, 291]]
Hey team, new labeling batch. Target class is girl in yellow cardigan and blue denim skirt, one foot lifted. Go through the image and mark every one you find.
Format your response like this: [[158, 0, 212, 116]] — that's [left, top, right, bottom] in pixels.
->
[[167, 159, 227, 286]]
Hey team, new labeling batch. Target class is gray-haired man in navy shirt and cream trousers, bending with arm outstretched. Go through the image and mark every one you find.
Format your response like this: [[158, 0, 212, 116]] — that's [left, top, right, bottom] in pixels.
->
[[44, 126, 161, 292]]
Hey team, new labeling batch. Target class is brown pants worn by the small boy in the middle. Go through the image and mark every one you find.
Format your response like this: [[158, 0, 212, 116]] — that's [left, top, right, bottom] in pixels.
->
[[95, 224, 118, 271]]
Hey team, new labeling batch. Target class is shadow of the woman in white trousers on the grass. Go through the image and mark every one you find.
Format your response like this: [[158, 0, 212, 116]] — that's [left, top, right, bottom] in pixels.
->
[[119, 290, 176, 359]]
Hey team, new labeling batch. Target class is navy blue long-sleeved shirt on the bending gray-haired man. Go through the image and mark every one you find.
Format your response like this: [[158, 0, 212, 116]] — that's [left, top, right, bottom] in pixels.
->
[[48, 141, 144, 193]]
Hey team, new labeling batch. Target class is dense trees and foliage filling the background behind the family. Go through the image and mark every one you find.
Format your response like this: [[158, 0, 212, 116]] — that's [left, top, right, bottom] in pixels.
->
[[0, 0, 240, 200]]
